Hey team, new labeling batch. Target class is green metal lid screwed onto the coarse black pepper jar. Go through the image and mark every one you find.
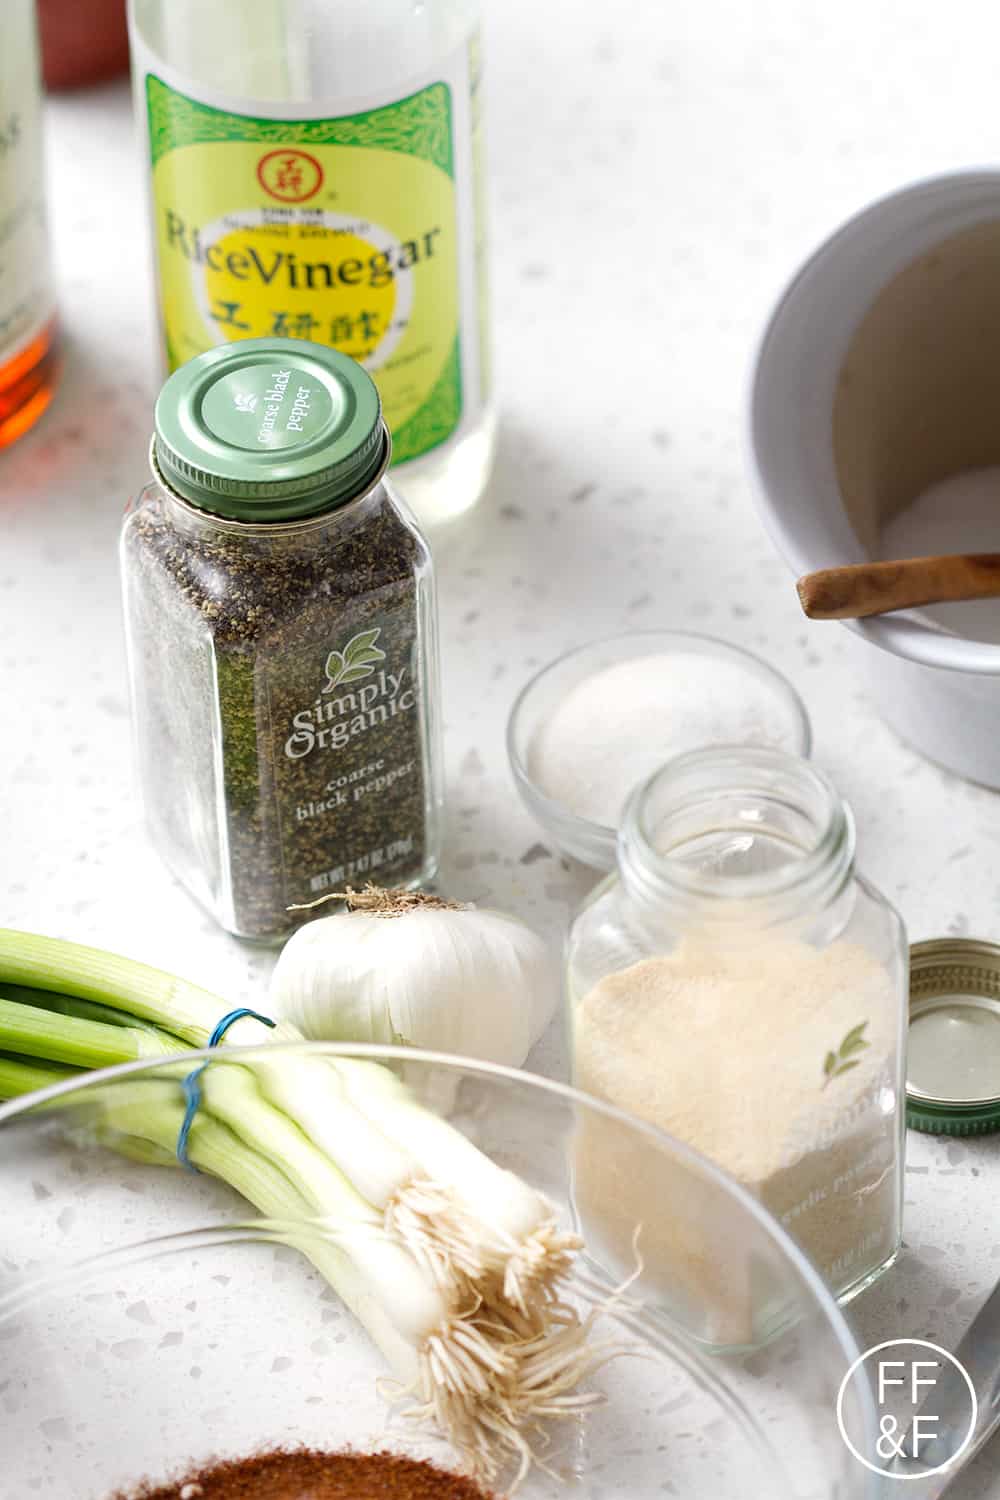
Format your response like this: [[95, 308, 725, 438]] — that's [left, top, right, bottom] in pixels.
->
[[153, 339, 388, 522]]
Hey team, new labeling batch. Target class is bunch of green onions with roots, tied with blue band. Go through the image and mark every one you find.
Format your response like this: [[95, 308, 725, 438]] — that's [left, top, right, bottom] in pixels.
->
[[0, 930, 610, 1481]]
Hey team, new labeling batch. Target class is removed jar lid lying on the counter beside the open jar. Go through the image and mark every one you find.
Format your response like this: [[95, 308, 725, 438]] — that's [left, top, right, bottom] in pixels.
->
[[906, 938, 1000, 1136]]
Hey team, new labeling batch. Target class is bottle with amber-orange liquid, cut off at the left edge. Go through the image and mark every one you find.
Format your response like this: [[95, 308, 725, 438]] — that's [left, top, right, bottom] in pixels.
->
[[0, 0, 57, 449]]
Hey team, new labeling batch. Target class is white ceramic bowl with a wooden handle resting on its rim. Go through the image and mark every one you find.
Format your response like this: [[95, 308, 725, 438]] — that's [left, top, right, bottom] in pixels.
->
[[748, 170, 1000, 786]]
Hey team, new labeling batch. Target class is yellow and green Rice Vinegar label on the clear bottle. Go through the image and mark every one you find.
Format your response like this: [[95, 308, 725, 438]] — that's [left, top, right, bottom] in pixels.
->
[[145, 74, 465, 462]]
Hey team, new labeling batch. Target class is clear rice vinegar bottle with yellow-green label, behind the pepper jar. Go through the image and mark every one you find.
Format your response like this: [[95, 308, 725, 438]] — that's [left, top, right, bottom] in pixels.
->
[[130, 0, 495, 527]]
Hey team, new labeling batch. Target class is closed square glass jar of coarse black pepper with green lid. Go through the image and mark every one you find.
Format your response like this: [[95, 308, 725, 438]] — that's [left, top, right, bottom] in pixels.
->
[[121, 339, 441, 941]]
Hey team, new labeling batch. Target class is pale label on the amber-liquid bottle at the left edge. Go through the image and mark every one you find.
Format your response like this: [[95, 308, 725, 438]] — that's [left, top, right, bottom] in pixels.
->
[[0, 5, 52, 365]]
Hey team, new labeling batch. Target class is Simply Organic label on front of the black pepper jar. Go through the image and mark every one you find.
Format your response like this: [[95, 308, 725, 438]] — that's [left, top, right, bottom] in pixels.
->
[[268, 609, 424, 905]]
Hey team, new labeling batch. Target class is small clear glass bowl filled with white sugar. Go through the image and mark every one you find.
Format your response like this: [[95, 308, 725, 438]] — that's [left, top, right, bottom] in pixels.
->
[[507, 630, 813, 870]]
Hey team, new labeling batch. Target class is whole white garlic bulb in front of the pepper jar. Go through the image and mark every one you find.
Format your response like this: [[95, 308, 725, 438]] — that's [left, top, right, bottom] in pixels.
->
[[270, 887, 558, 1068]]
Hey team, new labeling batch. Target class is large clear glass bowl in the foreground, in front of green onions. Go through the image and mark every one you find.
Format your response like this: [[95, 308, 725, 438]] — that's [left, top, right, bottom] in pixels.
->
[[0, 1044, 874, 1500]]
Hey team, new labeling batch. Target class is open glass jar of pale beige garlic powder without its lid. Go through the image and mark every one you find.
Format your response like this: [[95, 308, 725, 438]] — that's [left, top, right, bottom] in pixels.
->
[[568, 746, 909, 1308]]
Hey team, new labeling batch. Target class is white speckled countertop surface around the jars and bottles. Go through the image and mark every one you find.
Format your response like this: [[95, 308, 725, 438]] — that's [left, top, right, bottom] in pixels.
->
[[0, 0, 1000, 1500]]
